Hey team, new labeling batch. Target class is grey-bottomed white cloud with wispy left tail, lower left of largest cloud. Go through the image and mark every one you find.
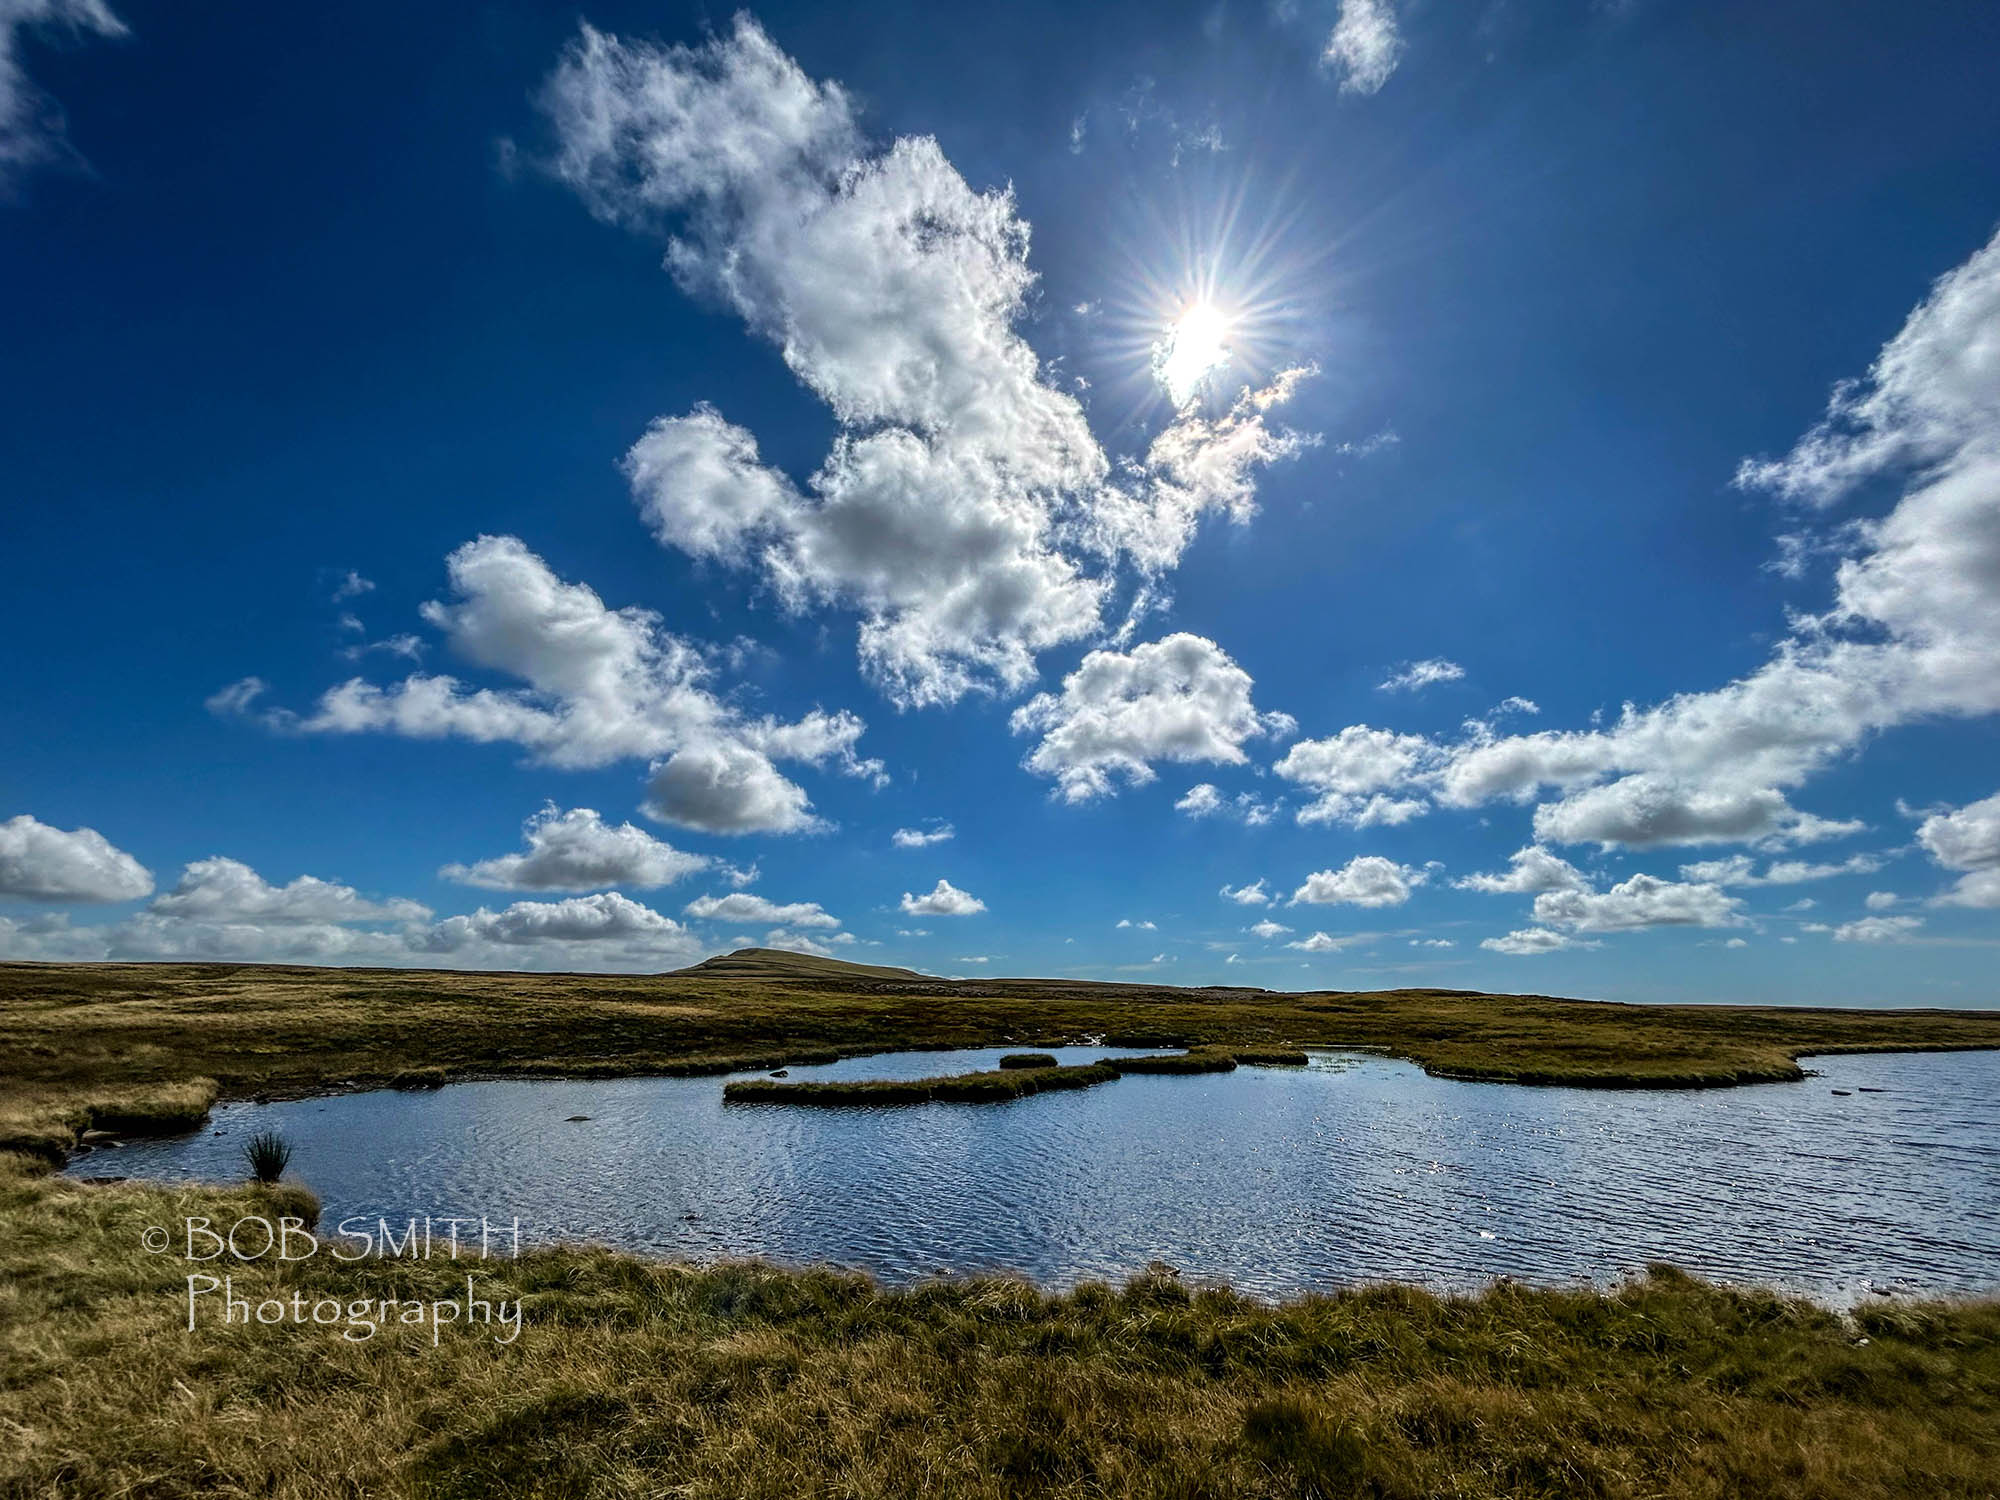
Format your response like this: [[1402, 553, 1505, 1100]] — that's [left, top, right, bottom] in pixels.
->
[[274, 536, 882, 834]]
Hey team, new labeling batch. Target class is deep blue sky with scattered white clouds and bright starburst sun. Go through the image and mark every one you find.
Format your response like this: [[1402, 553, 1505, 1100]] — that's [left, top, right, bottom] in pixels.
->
[[0, 0, 2000, 1006]]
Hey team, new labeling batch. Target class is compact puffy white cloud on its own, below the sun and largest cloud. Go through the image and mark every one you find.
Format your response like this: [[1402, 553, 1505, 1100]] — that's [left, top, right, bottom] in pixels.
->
[[1012, 634, 1294, 802]]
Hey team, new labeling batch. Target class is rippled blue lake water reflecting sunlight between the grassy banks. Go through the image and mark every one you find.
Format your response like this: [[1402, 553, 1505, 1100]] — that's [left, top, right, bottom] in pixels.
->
[[70, 1048, 2000, 1300]]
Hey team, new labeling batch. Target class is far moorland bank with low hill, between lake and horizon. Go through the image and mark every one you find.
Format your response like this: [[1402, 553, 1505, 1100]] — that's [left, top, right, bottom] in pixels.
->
[[0, 954, 2000, 1154]]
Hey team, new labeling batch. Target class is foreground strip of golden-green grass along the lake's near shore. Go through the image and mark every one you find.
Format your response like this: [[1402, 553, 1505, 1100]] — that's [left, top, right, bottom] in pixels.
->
[[0, 1158, 2000, 1500]]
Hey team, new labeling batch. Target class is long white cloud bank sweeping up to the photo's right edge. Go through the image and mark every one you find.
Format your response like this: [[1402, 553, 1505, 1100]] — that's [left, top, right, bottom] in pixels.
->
[[1408, 234, 2000, 846]]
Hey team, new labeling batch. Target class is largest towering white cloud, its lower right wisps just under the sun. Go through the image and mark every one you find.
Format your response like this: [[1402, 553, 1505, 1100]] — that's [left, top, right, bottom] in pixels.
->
[[544, 16, 1304, 704]]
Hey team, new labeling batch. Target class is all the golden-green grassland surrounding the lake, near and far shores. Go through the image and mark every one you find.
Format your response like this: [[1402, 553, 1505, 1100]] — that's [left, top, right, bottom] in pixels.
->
[[0, 956, 2000, 1500]]
